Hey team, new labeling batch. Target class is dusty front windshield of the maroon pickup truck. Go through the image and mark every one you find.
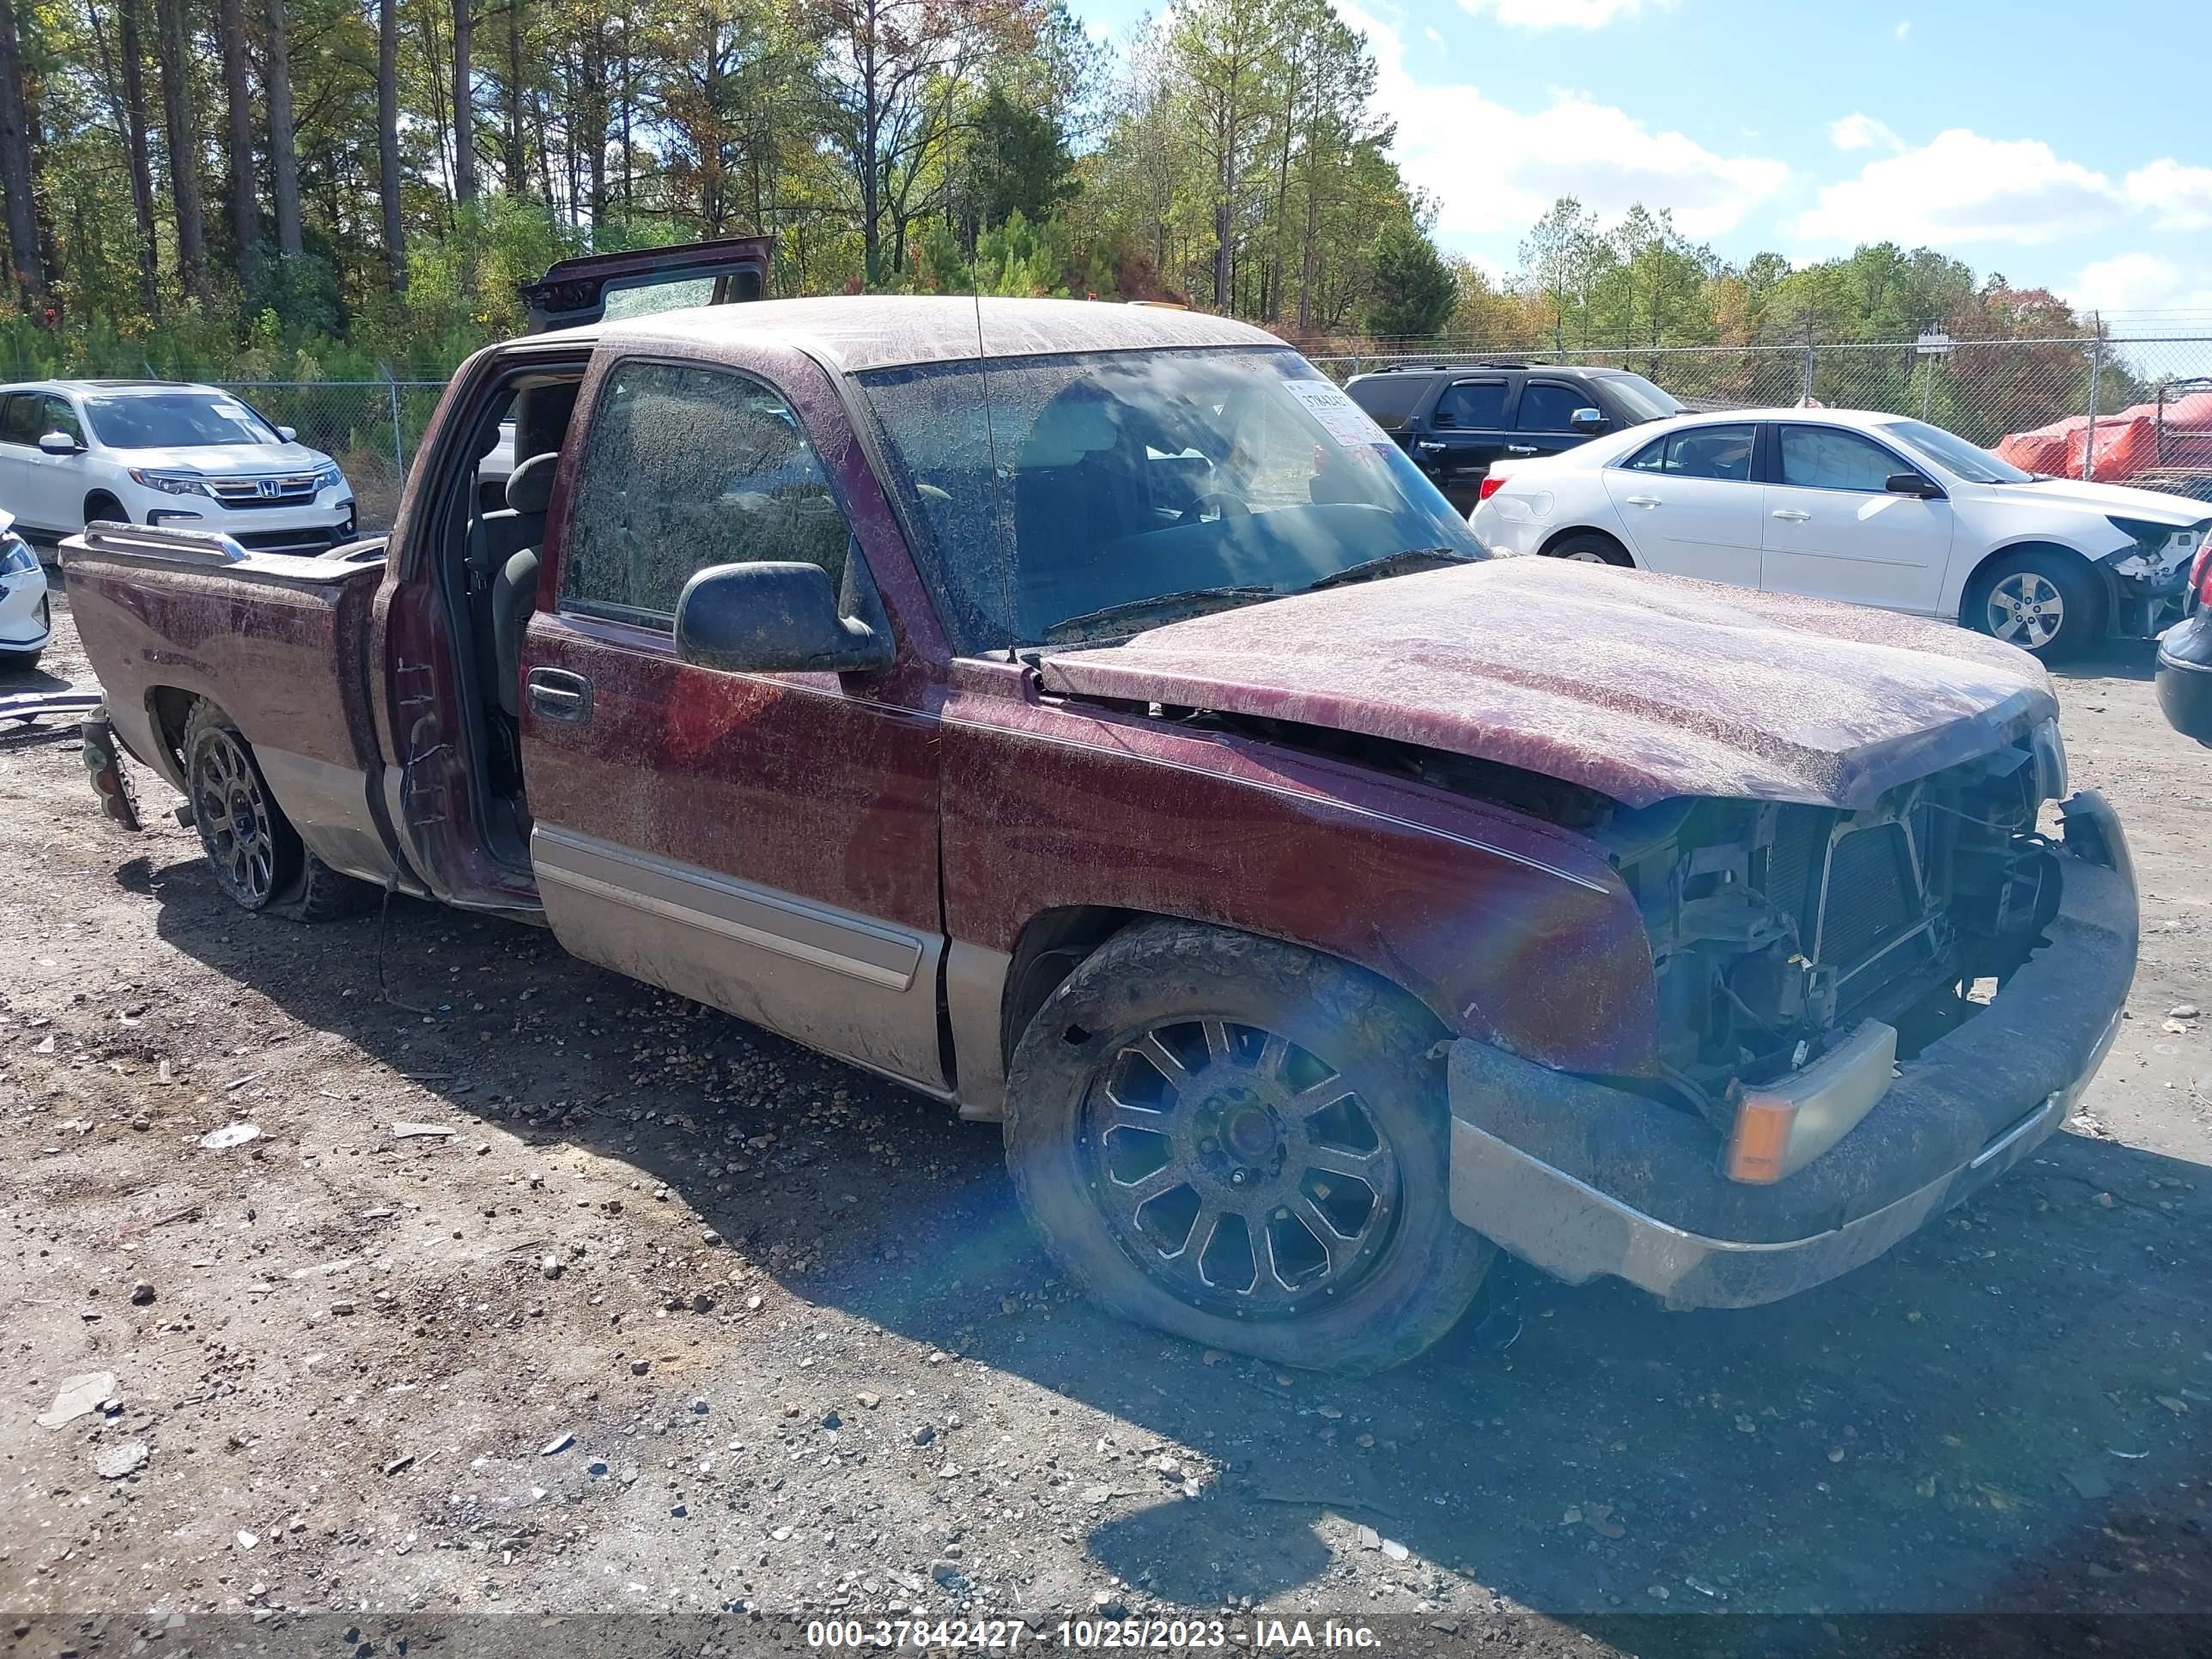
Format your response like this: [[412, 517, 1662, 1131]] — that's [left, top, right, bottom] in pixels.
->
[[860, 347, 1484, 653]]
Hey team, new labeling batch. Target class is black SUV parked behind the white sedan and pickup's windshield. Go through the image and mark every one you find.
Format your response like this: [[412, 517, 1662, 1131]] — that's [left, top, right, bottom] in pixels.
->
[[1345, 362, 1683, 514]]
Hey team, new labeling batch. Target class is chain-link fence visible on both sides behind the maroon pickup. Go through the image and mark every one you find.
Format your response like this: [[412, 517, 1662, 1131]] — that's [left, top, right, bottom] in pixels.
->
[[226, 334, 2212, 531]]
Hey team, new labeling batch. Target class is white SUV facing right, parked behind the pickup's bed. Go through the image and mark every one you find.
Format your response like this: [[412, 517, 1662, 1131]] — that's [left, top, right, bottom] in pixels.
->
[[0, 380, 354, 553]]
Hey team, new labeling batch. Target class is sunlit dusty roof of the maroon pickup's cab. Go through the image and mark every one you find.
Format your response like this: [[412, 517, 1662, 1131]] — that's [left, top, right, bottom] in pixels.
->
[[579, 295, 1283, 374]]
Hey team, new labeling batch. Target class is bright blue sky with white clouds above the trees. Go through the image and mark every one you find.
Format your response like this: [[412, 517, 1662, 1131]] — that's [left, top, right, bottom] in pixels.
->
[[1071, 0, 2212, 330]]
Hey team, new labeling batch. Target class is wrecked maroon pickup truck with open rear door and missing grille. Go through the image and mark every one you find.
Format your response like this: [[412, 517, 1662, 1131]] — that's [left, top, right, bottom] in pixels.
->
[[64, 234, 2136, 1371]]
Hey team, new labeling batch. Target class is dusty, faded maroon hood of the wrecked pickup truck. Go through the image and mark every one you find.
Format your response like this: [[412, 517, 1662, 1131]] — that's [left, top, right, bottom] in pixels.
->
[[1040, 560, 2057, 810]]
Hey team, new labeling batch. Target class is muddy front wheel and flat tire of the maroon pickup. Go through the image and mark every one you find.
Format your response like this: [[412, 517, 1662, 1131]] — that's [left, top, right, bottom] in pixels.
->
[[1005, 922, 1495, 1376]]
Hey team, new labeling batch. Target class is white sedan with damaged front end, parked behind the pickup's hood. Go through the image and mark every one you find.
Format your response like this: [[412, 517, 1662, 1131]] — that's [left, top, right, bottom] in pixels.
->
[[1468, 410, 2212, 657]]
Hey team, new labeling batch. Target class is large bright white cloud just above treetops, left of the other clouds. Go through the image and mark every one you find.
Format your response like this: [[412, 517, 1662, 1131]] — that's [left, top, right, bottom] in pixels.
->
[[1336, 0, 1790, 241]]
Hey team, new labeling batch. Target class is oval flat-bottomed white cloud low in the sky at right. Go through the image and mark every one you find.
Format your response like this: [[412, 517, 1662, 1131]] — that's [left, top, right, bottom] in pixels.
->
[[1796, 126, 2128, 248]]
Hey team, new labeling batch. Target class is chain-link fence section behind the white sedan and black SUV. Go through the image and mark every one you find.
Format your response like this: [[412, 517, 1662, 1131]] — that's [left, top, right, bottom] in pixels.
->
[[1314, 334, 2212, 500]]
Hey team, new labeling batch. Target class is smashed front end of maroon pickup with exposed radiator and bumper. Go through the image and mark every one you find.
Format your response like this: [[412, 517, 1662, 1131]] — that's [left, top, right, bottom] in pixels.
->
[[1449, 726, 2136, 1307]]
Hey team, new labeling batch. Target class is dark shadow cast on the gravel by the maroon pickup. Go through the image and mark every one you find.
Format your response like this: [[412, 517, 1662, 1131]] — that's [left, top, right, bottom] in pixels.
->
[[143, 860, 2212, 1652]]
